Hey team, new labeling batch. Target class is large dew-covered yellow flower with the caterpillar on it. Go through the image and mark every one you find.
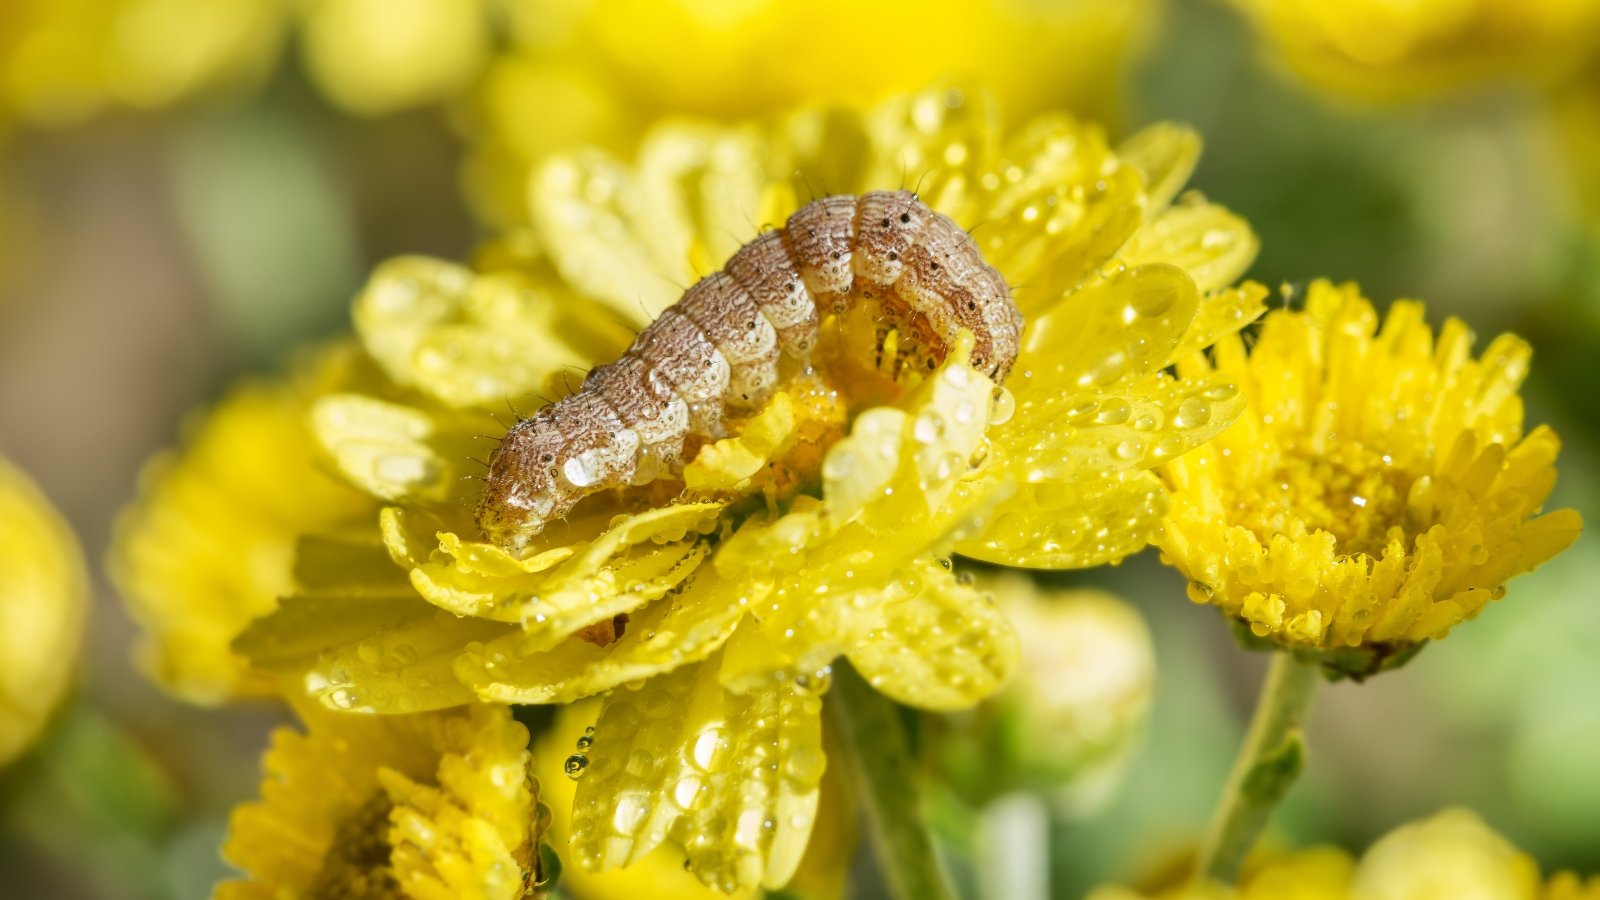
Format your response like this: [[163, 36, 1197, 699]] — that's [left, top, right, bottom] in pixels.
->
[[228, 90, 1264, 887]]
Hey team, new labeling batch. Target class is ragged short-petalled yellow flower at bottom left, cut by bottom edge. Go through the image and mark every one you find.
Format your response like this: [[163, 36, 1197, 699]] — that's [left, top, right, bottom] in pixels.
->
[[216, 705, 542, 900]]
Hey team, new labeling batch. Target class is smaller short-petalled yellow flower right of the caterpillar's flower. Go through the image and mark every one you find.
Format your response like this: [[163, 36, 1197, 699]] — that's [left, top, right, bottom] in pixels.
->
[[1160, 282, 1581, 677]]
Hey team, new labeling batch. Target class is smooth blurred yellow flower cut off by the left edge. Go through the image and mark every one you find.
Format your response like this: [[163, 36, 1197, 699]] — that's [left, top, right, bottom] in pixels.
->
[[0, 458, 88, 765]]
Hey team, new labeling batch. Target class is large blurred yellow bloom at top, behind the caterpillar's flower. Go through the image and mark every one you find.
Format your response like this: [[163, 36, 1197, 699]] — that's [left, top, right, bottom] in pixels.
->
[[469, 0, 1158, 223]]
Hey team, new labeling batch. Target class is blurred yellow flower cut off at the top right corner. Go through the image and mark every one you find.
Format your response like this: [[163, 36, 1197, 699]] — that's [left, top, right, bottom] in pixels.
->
[[1234, 0, 1600, 98]]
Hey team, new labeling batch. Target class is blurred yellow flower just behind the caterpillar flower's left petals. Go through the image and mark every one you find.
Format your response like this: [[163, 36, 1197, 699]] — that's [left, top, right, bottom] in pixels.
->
[[110, 351, 374, 705]]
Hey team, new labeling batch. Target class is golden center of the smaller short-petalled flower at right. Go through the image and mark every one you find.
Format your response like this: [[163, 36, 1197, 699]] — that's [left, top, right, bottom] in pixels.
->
[[1237, 440, 1421, 557]]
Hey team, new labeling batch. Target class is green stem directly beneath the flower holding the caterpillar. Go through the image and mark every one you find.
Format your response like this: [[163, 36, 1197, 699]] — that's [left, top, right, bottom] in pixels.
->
[[827, 660, 955, 900]]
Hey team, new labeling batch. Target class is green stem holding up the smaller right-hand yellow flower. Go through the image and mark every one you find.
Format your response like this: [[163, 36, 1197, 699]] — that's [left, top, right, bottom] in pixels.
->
[[1195, 652, 1322, 886]]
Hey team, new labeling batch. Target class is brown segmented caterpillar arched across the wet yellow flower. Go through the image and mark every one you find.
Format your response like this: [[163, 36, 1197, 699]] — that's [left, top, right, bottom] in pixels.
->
[[477, 191, 1022, 551]]
